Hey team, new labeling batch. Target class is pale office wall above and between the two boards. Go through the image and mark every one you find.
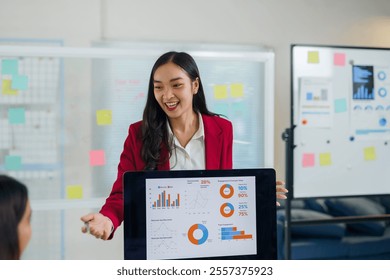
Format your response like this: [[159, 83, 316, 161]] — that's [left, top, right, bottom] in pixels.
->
[[0, 0, 390, 258]]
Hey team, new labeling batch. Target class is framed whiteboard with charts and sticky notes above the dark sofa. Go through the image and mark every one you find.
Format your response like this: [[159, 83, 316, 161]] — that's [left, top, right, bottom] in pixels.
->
[[291, 45, 390, 198]]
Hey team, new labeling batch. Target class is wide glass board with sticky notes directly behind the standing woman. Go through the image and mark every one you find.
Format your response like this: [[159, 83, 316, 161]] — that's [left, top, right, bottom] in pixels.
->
[[0, 43, 274, 259]]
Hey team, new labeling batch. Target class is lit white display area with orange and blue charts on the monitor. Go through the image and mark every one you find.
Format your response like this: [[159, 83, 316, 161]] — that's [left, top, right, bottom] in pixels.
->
[[146, 176, 257, 259]]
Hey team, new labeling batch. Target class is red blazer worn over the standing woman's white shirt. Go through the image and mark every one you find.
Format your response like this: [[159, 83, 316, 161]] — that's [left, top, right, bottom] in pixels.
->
[[100, 115, 233, 234]]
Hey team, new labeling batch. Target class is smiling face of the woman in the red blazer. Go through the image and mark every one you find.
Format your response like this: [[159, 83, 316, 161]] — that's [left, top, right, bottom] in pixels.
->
[[153, 62, 199, 119]]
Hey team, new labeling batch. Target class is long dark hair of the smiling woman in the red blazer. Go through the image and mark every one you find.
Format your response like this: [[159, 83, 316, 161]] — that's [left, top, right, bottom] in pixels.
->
[[141, 51, 216, 170]]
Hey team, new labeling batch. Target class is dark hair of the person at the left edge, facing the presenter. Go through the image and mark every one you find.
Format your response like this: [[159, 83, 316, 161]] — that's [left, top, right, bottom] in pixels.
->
[[0, 175, 28, 260]]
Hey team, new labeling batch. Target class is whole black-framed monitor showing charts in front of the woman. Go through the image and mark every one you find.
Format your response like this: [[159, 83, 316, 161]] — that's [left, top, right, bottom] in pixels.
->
[[123, 169, 277, 260]]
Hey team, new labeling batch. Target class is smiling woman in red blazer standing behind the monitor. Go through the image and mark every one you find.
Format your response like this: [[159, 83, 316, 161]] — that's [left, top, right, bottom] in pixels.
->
[[81, 52, 286, 240]]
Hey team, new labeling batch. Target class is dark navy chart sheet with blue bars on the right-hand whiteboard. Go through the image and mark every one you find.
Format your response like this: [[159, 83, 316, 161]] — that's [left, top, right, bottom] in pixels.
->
[[352, 65, 374, 100]]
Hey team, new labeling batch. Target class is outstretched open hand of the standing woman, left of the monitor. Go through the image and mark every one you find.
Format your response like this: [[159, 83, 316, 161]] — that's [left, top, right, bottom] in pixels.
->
[[81, 213, 114, 240]]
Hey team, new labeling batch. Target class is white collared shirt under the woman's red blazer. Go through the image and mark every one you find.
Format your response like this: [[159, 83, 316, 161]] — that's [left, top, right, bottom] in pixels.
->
[[167, 113, 206, 170]]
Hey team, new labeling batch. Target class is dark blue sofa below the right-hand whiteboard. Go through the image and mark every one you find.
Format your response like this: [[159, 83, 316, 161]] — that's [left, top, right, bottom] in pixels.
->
[[277, 196, 390, 260]]
